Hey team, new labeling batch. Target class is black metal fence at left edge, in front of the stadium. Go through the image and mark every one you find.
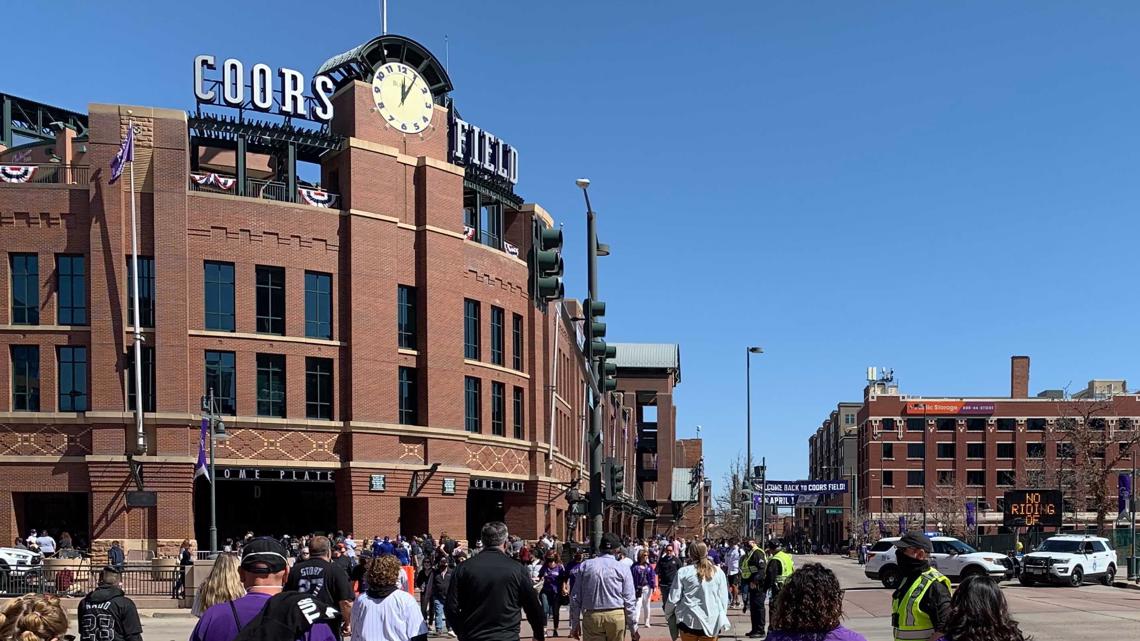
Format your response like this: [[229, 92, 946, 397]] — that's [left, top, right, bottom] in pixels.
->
[[0, 566, 182, 598]]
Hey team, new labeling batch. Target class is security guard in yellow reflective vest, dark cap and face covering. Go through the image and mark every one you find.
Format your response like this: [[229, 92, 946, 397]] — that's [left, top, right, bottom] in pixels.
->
[[890, 532, 950, 641]]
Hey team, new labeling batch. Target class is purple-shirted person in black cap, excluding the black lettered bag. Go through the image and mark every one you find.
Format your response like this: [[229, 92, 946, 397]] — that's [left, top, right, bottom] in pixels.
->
[[190, 537, 335, 641]]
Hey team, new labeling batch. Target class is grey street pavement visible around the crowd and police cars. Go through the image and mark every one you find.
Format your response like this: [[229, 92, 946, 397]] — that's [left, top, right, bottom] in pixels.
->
[[72, 555, 1140, 641]]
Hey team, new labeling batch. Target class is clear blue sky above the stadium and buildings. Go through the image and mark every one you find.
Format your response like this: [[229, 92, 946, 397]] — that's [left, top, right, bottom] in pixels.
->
[[11, 0, 1140, 484]]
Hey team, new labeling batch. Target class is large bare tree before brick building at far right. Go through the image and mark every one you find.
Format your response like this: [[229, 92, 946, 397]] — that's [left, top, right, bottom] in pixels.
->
[[1053, 397, 1140, 536]]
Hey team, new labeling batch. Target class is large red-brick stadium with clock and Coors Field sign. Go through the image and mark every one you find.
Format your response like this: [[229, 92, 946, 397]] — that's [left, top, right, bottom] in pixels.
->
[[0, 35, 693, 552]]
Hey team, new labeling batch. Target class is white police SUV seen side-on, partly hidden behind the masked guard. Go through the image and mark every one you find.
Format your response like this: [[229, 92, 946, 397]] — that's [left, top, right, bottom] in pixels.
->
[[863, 536, 1012, 590]]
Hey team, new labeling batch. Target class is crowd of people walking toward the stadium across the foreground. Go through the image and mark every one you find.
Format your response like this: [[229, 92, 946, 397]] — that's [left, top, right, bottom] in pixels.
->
[[0, 522, 1027, 641]]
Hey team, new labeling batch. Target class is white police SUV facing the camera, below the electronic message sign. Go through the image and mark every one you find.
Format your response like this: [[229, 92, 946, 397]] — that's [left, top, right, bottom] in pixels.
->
[[1020, 534, 1116, 587]]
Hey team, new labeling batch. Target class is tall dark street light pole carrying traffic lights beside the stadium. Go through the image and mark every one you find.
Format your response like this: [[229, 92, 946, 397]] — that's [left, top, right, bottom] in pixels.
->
[[575, 178, 609, 551]]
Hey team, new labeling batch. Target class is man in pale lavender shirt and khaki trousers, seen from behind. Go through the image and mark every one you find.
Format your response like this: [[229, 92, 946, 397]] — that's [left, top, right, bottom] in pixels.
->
[[570, 533, 641, 641]]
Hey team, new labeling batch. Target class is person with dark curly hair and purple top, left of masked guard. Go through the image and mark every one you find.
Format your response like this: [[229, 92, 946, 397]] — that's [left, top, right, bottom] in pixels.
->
[[767, 563, 866, 641]]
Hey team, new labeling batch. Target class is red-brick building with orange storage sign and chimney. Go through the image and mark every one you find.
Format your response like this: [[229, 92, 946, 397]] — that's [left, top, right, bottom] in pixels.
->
[[852, 356, 1140, 541]]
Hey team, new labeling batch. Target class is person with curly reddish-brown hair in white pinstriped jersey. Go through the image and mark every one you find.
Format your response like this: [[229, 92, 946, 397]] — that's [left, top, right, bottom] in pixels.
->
[[351, 555, 428, 641]]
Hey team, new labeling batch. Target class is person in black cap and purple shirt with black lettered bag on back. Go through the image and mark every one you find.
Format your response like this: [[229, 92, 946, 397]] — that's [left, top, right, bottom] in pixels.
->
[[186, 537, 336, 641]]
